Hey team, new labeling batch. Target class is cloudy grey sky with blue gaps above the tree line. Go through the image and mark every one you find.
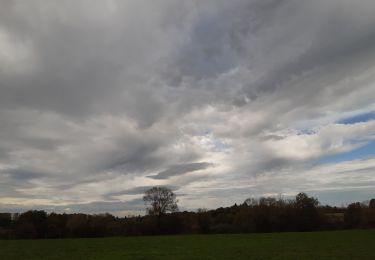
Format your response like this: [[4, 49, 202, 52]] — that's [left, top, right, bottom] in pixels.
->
[[0, 0, 375, 216]]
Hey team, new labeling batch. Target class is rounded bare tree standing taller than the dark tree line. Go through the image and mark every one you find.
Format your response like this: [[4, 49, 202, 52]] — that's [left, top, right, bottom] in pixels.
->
[[143, 187, 178, 216]]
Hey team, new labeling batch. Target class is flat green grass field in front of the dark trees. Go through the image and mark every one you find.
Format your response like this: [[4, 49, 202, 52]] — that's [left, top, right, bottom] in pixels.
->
[[0, 230, 375, 260]]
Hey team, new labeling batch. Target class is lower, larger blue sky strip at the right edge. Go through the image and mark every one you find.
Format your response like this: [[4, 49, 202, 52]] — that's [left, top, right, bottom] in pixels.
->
[[316, 140, 375, 164]]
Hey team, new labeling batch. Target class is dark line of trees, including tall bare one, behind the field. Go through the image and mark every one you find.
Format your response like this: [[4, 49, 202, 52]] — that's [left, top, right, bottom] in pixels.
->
[[0, 188, 375, 239]]
